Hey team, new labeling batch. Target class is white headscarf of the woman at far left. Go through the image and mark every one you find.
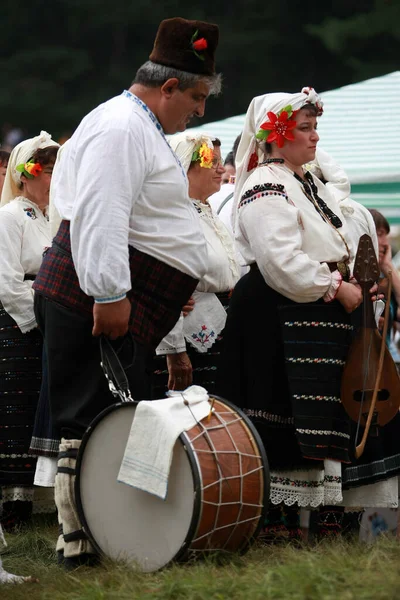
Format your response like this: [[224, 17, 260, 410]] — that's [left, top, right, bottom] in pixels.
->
[[0, 131, 59, 206]]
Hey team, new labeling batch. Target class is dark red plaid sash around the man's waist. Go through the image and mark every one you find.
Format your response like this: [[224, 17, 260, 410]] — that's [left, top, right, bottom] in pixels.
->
[[33, 221, 198, 348]]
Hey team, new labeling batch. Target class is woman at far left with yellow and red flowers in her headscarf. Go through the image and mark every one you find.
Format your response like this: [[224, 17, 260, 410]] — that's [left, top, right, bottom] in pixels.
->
[[0, 131, 58, 529]]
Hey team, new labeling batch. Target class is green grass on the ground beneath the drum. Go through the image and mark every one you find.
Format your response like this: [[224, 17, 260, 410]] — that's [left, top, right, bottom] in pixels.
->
[[0, 520, 400, 600]]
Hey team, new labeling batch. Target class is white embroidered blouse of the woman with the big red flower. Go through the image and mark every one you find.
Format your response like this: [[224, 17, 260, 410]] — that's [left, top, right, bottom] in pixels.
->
[[236, 164, 354, 302]]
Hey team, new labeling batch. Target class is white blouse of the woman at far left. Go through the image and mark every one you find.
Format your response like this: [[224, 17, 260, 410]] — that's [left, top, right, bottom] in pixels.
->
[[0, 197, 51, 333]]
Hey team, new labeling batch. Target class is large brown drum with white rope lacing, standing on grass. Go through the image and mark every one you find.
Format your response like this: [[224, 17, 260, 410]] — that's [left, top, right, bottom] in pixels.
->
[[75, 398, 269, 571]]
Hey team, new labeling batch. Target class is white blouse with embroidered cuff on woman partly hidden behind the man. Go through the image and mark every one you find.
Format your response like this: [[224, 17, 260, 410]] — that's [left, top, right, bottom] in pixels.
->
[[156, 200, 239, 355]]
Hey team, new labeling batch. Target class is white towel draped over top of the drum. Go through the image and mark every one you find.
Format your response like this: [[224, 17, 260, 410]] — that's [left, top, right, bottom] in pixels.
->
[[118, 385, 210, 500]]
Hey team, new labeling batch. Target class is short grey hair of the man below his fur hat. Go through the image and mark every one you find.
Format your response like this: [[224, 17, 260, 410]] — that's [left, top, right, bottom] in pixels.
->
[[133, 60, 222, 95]]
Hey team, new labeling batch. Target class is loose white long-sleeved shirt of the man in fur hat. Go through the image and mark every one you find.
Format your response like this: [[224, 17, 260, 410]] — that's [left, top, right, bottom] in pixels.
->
[[52, 92, 207, 302]]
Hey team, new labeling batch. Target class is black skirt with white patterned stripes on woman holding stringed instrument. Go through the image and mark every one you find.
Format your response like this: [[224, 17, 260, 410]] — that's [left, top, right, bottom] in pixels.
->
[[216, 268, 400, 487]]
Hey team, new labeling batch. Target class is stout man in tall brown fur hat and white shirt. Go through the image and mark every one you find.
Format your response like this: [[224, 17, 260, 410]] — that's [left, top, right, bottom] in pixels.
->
[[34, 18, 220, 567]]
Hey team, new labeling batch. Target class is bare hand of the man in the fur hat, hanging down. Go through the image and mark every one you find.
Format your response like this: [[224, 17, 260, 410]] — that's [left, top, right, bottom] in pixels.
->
[[92, 298, 131, 340]]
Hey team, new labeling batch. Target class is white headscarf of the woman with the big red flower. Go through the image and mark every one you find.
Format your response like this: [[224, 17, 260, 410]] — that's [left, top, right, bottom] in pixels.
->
[[234, 87, 323, 230]]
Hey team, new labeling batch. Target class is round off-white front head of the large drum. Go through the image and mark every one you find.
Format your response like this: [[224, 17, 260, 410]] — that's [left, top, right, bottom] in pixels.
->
[[76, 403, 200, 571]]
